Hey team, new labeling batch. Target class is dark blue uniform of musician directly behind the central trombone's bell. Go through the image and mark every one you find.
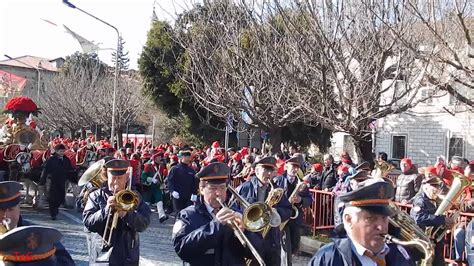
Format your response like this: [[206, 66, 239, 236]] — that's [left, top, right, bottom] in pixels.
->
[[237, 176, 292, 265]]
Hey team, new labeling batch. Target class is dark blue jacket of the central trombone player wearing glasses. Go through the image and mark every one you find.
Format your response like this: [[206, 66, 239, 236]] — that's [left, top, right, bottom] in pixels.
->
[[173, 197, 246, 266]]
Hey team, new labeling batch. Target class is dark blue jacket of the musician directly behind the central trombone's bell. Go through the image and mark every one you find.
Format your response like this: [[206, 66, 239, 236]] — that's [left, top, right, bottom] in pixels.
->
[[236, 176, 292, 257]]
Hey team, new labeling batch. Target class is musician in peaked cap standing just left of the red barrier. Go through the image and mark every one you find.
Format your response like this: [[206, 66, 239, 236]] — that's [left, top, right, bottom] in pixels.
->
[[276, 157, 313, 265]]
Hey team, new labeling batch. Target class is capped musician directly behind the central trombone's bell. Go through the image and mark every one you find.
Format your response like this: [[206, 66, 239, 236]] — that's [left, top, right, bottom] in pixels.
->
[[237, 157, 292, 266]]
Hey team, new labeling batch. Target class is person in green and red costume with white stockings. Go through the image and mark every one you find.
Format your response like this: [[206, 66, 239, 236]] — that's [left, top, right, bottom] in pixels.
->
[[141, 152, 168, 223]]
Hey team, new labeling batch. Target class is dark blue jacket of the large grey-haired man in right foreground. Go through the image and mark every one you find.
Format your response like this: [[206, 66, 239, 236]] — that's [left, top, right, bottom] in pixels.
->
[[308, 238, 416, 266]]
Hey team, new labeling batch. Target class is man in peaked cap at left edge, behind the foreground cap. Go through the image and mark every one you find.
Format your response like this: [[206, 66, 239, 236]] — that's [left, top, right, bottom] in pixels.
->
[[0, 181, 75, 266]]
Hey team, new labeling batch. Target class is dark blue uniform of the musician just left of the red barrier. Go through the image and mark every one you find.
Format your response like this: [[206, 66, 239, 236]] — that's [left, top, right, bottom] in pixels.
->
[[276, 172, 313, 265]]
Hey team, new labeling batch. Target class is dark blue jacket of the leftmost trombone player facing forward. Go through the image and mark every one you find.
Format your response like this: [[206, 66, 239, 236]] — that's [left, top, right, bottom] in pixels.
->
[[82, 185, 151, 265]]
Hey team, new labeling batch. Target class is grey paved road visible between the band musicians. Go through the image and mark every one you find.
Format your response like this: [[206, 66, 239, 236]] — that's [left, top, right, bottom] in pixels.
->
[[21, 195, 309, 266]]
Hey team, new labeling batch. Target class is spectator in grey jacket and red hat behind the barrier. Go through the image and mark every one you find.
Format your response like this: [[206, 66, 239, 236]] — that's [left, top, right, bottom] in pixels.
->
[[395, 158, 423, 204]]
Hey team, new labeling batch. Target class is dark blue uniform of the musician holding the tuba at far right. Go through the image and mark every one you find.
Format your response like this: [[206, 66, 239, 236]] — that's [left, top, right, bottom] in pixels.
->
[[410, 192, 445, 265]]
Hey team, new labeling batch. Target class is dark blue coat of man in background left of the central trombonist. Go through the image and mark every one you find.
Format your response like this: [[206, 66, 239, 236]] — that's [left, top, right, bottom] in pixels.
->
[[168, 163, 199, 211]]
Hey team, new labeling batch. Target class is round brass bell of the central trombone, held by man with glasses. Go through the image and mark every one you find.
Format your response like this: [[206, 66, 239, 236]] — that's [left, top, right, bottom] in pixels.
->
[[227, 186, 272, 232]]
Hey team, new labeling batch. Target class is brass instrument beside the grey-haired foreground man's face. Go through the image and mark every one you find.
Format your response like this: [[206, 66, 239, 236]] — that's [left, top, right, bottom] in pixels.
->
[[385, 202, 434, 266]]
